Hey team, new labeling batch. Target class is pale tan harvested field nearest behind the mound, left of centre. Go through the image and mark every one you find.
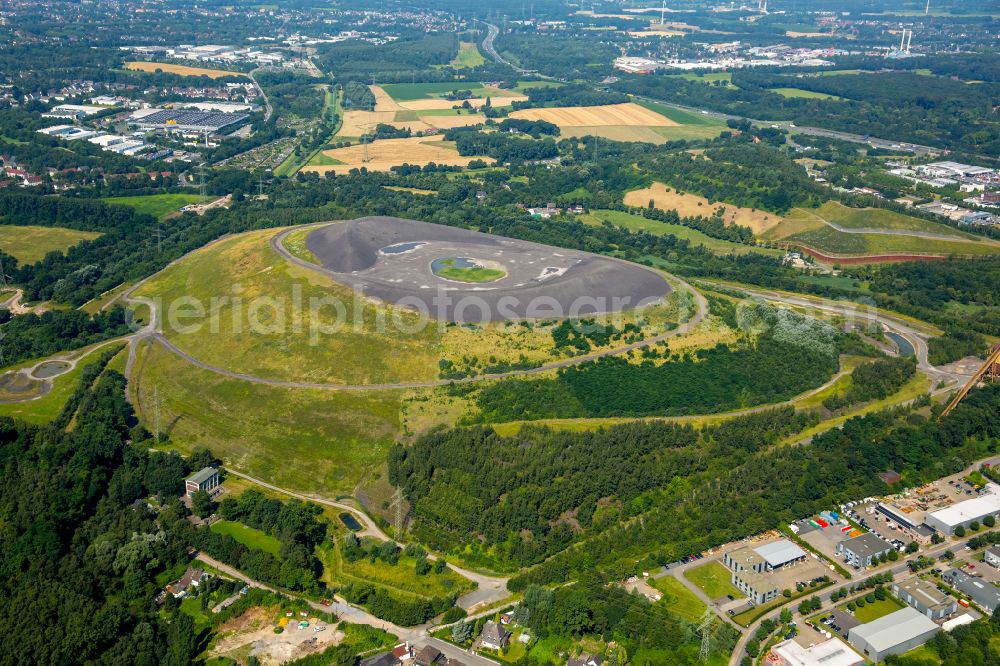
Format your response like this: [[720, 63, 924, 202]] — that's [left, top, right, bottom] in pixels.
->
[[302, 136, 488, 174]]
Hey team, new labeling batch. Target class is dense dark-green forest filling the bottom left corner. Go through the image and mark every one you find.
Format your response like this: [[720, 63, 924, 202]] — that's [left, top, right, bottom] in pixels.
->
[[0, 364, 208, 666]]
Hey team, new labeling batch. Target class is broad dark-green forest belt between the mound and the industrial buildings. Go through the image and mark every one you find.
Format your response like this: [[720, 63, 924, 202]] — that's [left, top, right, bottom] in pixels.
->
[[389, 374, 1000, 576]]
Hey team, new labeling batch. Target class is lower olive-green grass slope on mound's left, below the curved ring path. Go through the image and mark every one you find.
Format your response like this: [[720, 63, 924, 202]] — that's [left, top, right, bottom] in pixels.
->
[[129, 345, 399, 490]]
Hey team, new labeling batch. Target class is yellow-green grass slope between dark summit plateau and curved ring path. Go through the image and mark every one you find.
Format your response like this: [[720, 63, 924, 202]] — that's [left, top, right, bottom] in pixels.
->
[[137, 229, 439, 384]]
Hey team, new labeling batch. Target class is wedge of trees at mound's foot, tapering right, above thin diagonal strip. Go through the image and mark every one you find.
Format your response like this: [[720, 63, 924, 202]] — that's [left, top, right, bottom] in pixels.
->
[[389, 409, 812, 566]]
